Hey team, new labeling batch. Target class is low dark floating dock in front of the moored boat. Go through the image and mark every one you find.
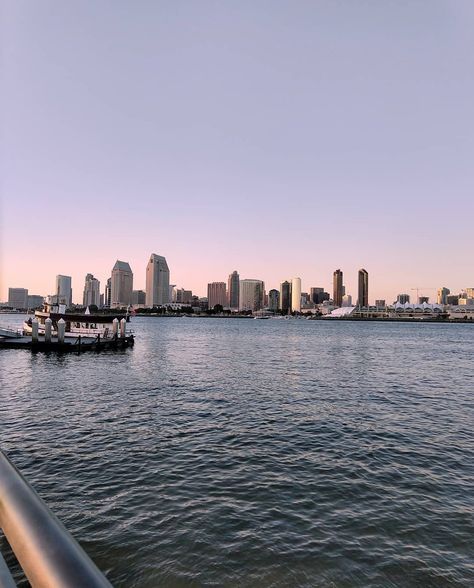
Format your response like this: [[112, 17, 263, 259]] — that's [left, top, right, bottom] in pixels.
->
[[0, 335, 134, 353]]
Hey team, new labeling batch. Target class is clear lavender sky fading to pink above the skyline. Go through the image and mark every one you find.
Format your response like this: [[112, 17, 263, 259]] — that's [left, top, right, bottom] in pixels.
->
[[0, 0, 474, 302]]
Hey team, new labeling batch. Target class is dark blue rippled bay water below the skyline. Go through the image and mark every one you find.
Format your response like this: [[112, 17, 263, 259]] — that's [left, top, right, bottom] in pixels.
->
[[0, 318, 474, 587]]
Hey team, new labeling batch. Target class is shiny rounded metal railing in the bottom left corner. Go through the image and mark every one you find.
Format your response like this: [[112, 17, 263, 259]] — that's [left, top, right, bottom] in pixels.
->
[[0, 451, 111, 588]]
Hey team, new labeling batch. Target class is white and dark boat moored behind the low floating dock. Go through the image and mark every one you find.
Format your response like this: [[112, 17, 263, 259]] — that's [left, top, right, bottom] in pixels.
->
[[23, 302, 132, 339]]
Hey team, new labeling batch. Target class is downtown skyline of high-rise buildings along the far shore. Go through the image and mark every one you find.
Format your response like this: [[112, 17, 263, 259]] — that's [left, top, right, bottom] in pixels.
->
[[3, 253, 474, 315]]
